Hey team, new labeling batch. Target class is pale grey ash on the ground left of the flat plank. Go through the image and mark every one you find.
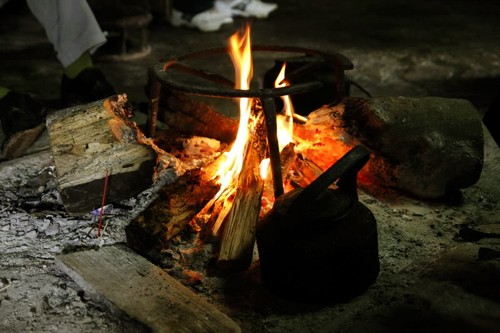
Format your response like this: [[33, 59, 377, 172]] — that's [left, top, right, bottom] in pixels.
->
[[0, 150, 166, 332]]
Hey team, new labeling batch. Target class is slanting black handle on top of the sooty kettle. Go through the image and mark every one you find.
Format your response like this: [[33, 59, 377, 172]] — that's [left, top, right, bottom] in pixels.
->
[[293, 145, 370, 208]]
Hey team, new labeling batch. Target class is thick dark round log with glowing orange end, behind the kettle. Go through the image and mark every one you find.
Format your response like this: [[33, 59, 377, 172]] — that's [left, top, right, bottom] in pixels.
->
[[297, 97, 484, 199]]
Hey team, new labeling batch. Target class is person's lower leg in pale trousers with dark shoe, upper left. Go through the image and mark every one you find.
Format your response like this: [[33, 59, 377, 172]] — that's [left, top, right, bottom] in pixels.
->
[[27, 0, 115, 106]]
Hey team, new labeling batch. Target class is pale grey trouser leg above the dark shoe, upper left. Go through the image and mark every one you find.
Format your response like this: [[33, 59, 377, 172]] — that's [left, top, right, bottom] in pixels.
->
[[0, 0, 106, 67]]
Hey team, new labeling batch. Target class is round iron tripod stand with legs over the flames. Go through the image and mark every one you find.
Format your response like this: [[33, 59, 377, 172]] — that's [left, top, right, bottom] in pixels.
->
[[147, 45, 353, 197]]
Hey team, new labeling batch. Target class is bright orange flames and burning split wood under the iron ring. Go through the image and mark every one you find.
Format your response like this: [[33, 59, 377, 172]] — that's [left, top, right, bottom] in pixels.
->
[[137, 26, 368, 269]]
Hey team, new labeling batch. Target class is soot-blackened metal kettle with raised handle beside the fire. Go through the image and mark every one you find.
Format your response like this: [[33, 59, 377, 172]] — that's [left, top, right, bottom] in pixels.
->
[[256, 145, 380, 303]]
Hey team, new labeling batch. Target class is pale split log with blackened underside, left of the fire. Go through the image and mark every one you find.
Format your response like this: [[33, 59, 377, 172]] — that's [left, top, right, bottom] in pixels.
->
[[46, 95, 175, 215]]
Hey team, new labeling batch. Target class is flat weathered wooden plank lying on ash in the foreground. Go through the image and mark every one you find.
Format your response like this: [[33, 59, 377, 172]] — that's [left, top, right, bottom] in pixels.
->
[[56, 246, 241, 333]]
